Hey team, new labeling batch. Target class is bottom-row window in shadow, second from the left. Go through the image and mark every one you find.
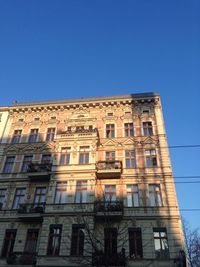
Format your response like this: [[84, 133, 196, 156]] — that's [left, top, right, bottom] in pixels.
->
[[24, 229, 39, 253]]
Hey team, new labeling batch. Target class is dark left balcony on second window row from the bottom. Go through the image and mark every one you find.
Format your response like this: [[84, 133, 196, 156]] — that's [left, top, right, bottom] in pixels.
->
[[17, 203, 45, 222]]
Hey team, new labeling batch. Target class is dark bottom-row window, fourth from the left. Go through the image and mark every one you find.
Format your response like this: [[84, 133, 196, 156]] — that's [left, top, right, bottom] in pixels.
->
[[71, 225, 85, 256]]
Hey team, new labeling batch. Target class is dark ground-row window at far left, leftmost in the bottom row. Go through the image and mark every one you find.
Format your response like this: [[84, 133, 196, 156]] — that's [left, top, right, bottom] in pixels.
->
[[2, 229, 17, 258]]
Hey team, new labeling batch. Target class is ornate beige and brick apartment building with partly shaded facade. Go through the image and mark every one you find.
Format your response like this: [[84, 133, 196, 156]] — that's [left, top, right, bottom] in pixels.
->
[[0, 93, 184, 267]]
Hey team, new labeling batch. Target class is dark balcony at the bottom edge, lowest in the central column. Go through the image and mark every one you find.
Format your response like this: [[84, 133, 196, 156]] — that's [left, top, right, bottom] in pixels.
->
[[92, 251, 126, 267]]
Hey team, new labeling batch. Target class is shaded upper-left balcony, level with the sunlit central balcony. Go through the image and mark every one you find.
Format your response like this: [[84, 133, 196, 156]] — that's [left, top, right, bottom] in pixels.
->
[[27, 161, 52, 182]]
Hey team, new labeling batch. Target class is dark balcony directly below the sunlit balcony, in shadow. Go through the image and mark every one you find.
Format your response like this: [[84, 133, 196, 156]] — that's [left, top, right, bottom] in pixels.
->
[[94, 200, 124, 221]]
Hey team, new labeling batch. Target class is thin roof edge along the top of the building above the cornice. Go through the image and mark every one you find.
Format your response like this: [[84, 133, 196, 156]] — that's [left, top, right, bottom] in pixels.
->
[[7, 92, 160, 107]]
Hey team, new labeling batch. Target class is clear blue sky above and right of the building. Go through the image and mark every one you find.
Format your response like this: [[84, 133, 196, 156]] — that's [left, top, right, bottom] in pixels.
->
[[0, 0, 200, 227]]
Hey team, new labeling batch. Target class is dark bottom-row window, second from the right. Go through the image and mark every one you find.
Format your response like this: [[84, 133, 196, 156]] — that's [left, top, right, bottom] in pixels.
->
[[128, 228, 143, 259]]
